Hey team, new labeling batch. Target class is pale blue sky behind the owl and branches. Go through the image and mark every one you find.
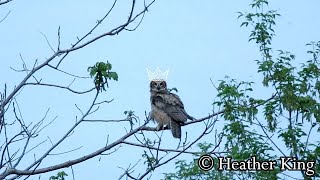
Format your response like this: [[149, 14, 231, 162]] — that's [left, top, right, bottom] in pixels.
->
[[0, 0, 320, 179]]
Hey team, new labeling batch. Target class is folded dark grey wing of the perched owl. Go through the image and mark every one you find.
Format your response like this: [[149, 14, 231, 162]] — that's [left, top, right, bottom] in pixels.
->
[[151, 93, 189, 122]]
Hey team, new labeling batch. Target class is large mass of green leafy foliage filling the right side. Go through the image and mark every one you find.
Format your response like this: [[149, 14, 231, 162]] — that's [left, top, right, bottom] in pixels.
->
[[165, 0, 320, 179]]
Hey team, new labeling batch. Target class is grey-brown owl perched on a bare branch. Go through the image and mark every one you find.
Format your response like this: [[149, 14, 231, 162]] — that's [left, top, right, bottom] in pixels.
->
[[150, 80, 194, 139]]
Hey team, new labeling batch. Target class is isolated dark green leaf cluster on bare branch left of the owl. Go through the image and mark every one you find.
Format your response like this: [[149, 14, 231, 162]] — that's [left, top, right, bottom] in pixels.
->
[[88, 61, 118, 91]]
